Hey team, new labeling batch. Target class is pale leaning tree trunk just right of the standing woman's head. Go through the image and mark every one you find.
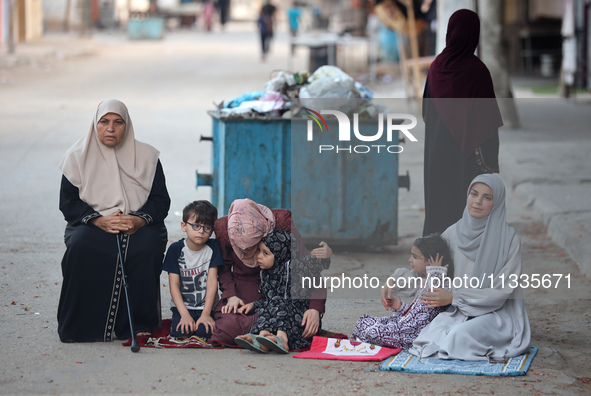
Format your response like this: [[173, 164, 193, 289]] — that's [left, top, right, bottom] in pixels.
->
[[478, 0, 519, 128]]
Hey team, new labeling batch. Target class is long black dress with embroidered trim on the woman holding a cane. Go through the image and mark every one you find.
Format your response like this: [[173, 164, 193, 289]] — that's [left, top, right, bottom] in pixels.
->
[[57, 161, 170, 342]]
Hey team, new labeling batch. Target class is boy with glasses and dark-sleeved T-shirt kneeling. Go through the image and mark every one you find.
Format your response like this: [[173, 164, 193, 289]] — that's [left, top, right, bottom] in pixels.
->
[[162, 201, 224, 338]]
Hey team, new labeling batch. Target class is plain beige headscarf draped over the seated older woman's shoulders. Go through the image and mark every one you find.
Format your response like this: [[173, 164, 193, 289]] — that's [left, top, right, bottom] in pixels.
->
[[60, 99, 160, 216]]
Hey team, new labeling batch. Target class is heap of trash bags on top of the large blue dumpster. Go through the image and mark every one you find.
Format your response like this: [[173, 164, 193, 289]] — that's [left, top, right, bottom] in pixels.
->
[[217, 66, 373, 119]]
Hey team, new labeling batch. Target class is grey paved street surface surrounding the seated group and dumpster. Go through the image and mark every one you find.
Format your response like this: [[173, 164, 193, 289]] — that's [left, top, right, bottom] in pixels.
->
[[0, 25, 591, 394]]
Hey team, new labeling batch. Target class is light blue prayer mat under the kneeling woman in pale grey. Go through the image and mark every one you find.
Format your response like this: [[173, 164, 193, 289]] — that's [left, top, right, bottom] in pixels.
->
[[380, 347, 538, 377]]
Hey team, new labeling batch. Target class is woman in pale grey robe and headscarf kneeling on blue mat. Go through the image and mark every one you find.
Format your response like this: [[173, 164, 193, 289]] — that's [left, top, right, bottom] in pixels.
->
[[410, 174, 531, 361]]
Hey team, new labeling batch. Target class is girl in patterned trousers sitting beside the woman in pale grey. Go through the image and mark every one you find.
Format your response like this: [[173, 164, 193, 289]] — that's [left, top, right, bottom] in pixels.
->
[[351, 234, 453, 349]]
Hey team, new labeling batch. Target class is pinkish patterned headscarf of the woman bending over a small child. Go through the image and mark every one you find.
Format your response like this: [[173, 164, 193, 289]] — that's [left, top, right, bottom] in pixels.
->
[[228, 198, 275, 268]]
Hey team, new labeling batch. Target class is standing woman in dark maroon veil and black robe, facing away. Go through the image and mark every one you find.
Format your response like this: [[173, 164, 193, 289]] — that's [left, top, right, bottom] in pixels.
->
[[423, 9, 503, 235]]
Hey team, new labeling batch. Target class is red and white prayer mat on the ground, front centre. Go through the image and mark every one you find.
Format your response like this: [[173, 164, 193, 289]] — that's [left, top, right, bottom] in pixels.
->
[[293, 336, 402, 362]]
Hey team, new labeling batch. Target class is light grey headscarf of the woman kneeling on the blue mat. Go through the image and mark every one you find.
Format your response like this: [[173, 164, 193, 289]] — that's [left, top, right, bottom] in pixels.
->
[[456, 174, 515, 287]]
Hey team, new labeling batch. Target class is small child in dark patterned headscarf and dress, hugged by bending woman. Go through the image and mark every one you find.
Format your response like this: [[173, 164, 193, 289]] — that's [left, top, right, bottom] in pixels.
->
[[235, 229, 332, 353]]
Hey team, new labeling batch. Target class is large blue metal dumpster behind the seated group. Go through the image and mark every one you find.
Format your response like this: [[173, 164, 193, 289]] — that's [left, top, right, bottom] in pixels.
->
[[197, 111, 410, 246]]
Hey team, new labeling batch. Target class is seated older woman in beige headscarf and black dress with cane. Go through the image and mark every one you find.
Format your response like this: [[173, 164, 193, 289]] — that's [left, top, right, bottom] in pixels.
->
[[57, 99, 170, 342]]
